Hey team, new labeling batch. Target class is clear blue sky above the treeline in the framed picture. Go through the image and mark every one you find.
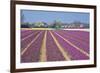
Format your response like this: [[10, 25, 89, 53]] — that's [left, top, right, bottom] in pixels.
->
[[21, 10, 89, 24]]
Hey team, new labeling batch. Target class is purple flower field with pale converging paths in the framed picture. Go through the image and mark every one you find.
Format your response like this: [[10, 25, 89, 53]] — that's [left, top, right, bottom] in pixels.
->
[[20, 30, 90, 63]]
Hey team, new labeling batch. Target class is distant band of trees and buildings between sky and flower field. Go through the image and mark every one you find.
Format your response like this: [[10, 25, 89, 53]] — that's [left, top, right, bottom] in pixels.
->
[[21, 21, 89, 29]]
